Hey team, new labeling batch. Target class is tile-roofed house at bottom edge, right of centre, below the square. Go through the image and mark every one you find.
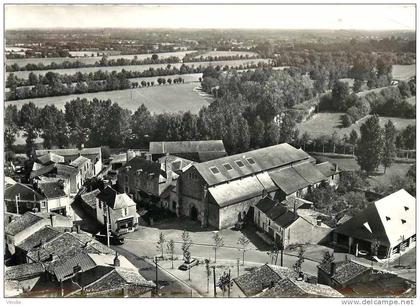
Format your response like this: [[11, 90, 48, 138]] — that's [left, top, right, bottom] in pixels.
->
[[230, 264, 342, 297]]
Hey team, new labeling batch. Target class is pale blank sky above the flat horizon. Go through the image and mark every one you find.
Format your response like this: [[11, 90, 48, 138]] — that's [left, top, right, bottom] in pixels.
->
[[5, 4, 415, 30]]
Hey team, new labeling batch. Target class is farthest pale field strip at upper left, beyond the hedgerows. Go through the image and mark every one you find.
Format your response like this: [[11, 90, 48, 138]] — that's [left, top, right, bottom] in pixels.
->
[[6, 51, 195, 66]]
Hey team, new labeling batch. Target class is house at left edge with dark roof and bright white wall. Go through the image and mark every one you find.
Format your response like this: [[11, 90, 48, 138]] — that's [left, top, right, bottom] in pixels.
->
[[4, 181, 73, 216]]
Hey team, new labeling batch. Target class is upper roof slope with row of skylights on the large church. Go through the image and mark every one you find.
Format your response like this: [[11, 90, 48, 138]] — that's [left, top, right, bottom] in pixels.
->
[[192, 143, 309, 186]]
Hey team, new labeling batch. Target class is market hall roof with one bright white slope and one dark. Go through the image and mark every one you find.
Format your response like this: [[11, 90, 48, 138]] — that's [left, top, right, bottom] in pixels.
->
[[335, 189, 416, 247]]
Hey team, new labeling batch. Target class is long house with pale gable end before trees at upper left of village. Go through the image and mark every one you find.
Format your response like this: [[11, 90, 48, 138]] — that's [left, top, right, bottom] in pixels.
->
[[35, 147, 102, 176]]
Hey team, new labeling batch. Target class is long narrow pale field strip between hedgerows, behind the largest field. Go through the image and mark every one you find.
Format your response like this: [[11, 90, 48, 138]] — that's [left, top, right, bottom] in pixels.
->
[[6, 59, 269, 79]]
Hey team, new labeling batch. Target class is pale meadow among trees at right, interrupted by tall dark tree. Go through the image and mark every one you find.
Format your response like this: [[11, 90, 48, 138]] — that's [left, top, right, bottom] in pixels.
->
[[297, 113, 416, 137]]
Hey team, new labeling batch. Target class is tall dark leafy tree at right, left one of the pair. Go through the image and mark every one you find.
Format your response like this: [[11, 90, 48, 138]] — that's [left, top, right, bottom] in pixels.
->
[[356, 115, 383, 175]]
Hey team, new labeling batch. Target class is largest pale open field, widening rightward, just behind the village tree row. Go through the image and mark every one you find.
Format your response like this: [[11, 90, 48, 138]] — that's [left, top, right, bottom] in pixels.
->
[[4, 83, 212, 113]]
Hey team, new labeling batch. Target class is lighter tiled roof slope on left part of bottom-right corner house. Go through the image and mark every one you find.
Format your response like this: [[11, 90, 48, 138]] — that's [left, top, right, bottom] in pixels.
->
[[318, 261, 371, 285]]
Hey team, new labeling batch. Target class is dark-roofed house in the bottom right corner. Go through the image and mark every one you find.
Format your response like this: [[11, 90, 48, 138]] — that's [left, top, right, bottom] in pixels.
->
[[318, 260, 415, 297]]
